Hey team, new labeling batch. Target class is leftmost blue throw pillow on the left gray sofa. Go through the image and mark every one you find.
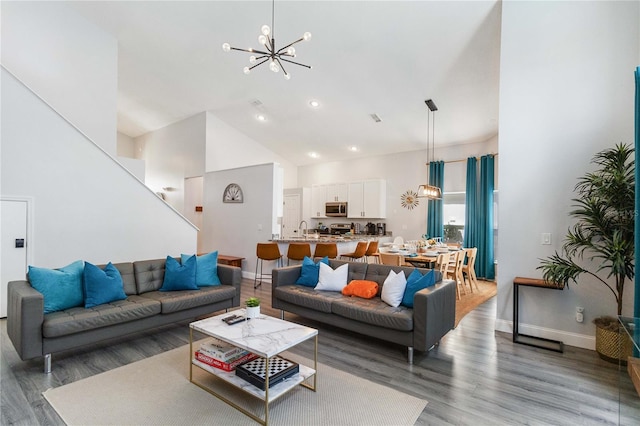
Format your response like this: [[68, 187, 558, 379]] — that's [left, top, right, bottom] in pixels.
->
[[28, 260, 84, 314]]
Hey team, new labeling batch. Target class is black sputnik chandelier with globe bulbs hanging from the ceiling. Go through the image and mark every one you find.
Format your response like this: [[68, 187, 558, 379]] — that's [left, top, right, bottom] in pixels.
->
[[222, 0, 311, 80]]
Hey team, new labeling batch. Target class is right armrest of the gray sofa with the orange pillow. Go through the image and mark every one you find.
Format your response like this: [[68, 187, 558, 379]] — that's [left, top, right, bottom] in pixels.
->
[[413, 280, 456, 351]]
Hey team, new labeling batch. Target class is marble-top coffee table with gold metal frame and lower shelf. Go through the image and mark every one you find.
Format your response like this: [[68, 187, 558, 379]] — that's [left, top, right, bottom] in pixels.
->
[[189, 309, 318, 425]]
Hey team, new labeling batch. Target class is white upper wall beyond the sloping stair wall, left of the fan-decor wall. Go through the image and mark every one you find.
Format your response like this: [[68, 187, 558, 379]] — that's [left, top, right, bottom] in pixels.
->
[[135, 112, 206, 213]]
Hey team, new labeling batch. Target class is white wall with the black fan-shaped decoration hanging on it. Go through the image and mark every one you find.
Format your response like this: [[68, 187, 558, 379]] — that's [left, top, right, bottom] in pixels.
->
[[201, 163, 277, 277]]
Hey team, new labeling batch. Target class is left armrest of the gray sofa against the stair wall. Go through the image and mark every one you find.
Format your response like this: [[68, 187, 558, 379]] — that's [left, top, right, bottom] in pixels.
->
[[7, 281, 44, 361]]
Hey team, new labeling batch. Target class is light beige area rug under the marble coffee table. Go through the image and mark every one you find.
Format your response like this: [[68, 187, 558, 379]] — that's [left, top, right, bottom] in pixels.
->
[[43, 345, 427, 426]]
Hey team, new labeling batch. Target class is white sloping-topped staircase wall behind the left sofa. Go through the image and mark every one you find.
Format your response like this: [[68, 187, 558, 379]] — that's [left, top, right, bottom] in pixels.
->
[[0, 70, 196, 267]]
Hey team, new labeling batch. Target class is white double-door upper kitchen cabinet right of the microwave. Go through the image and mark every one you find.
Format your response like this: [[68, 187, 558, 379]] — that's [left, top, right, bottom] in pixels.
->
[[347, 179, 387, 219]]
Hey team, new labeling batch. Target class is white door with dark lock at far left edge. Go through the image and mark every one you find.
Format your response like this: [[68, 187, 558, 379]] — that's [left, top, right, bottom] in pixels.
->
[[0, 200, 28, 318]]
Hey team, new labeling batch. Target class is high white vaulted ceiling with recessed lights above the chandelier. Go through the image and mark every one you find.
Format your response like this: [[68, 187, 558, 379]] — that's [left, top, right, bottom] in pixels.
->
[[68, 0, 501, 165]]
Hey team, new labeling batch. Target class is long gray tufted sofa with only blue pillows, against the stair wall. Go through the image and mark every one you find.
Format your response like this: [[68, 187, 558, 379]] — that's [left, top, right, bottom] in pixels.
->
[[7, 259, 242, 373]]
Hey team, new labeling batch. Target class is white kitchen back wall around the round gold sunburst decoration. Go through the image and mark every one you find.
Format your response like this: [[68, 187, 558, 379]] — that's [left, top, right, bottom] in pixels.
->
[[298, 138, 497, 240]]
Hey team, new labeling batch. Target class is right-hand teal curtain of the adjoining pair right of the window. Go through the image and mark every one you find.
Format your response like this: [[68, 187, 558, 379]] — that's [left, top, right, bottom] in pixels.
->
[[476, 155, 496, 280]]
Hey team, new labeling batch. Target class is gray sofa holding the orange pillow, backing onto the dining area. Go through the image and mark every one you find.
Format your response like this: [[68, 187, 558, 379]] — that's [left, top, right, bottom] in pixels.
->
[[271, 260, 456, 364]]
